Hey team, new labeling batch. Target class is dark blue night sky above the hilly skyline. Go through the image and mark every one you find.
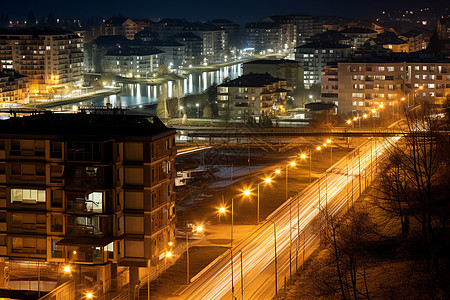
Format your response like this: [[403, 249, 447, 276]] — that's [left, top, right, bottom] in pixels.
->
[[0, 0, 448, 23]]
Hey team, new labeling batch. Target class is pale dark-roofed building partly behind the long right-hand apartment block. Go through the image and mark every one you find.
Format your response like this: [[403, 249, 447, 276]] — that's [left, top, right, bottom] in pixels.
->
[[295, 42, 351, 88]]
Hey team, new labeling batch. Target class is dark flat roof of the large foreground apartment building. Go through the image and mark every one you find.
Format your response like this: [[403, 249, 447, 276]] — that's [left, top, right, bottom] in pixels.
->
[[0, 109, 175, 141]]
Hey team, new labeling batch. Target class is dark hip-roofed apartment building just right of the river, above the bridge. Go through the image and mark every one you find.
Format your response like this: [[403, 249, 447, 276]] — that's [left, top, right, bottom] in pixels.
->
[[217, 74, 287, 120]]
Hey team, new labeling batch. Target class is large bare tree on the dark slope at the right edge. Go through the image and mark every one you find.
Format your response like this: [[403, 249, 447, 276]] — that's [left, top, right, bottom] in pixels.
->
[[375, 102, 450, 297]]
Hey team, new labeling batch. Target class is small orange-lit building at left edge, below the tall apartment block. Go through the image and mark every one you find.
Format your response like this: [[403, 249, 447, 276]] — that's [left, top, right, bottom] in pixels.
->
[[0, 72, 29, 108]]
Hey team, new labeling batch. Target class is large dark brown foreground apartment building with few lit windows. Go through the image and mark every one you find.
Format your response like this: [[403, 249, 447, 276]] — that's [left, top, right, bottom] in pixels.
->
[[0, 111, 176, 299]]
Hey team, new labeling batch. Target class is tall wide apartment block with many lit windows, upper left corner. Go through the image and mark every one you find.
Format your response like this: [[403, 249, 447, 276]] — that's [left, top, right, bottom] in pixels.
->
[[0, 27, 83, 96]]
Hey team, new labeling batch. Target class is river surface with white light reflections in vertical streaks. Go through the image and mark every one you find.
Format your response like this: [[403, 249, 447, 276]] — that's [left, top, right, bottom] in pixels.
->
[[83, 64, 242, 107]]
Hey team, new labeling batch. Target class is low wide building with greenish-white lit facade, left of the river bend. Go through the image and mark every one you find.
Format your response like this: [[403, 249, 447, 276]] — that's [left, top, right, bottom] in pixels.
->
[[103, 47, 164, 78]]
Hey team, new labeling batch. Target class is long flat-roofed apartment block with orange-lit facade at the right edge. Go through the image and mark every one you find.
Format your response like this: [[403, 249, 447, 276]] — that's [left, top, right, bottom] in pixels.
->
[[322, 56, 450, 113]]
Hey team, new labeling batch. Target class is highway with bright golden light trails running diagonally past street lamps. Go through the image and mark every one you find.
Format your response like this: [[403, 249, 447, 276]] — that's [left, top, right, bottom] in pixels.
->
[[173, 137, 398, 300]]
